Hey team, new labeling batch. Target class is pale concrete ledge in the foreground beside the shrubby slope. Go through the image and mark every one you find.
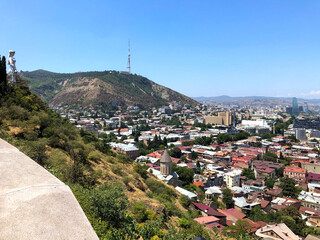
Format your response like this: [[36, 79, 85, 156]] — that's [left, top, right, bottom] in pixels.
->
[[0, 139, 98, 240]]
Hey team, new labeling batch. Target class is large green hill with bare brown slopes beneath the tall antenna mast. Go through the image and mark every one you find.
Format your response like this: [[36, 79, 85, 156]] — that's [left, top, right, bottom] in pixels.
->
[[20, 70, 198, 107]]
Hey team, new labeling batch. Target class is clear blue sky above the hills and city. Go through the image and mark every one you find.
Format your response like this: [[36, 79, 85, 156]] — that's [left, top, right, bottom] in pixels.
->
[[0, 0, 320, 98]]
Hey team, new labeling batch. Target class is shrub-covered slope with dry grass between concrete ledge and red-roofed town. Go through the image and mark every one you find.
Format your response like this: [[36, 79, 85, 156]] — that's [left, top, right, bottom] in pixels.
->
[[0, 81, 215, 240]]
